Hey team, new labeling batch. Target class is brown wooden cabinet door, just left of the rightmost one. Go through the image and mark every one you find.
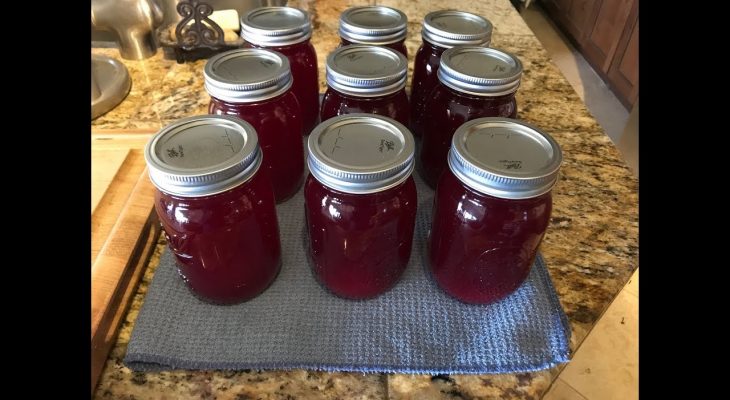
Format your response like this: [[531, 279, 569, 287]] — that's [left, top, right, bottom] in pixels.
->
[[582, 0, 635, 73]]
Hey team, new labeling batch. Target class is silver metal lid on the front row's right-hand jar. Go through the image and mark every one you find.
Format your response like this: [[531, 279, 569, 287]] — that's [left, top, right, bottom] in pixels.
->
[[448, 118, 563, 199]]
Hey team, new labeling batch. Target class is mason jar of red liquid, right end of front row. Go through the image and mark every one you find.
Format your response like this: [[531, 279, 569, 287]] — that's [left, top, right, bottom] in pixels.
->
[[428, 118, 563, 304]]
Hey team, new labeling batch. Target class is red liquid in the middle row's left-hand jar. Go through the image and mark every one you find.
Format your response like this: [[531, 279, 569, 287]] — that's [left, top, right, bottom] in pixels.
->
[[208, 90, 304, 202]]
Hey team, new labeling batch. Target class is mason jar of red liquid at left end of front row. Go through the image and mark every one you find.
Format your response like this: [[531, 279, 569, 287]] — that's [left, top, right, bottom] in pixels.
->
[[145, 115, 281, 304]]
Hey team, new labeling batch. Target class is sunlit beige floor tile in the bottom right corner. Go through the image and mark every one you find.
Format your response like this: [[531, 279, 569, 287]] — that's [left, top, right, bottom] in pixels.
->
[[559, 290, 639, 400]]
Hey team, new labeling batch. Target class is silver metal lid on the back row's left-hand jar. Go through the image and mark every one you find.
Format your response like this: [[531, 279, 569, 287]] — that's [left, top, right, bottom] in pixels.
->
[[241, 7, 312, 46]]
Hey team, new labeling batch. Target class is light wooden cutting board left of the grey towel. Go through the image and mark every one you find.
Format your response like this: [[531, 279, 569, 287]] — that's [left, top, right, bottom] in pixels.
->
[[91, 131, 160, 393]]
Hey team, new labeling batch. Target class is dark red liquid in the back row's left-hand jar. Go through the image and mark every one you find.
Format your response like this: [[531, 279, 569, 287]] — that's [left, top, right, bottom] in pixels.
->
[[246, 40, 319, 135]]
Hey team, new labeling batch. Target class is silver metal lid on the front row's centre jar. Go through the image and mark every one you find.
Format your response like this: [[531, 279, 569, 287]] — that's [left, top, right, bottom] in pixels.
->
[[307, 114, 415, 194]]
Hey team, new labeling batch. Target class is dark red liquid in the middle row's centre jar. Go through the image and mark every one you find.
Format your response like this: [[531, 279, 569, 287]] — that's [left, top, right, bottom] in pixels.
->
[[321, 88, 410, 126]]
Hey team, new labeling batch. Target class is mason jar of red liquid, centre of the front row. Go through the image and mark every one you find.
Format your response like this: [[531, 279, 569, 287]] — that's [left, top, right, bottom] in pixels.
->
[[304, 114, 417, 299]]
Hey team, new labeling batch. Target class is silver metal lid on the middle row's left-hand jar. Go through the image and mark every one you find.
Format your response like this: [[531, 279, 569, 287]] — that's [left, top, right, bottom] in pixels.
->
[[203, 49, 293, 103]]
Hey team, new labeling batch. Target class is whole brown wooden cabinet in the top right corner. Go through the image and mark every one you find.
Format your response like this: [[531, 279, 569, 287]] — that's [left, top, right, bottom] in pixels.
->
[[542, 0, 639, 109]]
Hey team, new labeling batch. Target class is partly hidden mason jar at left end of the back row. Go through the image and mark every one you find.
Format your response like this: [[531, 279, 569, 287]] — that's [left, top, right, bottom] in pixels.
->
[[241, 7, 319, 134]]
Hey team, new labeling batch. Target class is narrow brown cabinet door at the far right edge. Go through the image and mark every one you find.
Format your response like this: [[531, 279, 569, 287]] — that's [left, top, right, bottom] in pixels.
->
[[608, 10, 639, 108]]
